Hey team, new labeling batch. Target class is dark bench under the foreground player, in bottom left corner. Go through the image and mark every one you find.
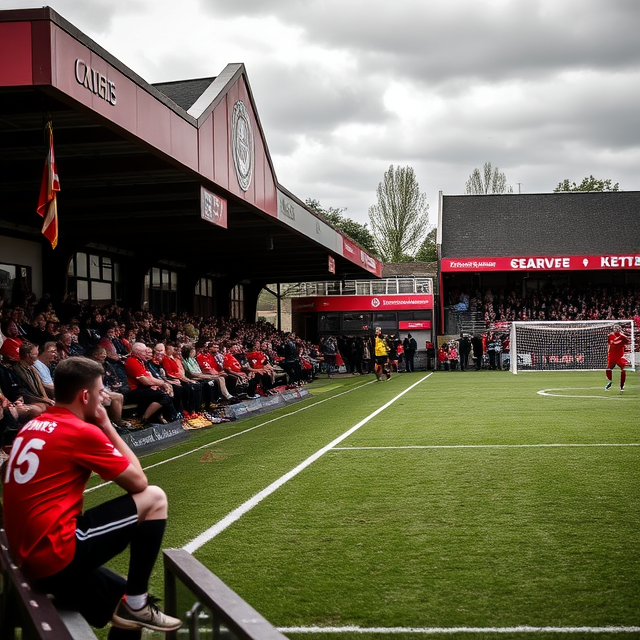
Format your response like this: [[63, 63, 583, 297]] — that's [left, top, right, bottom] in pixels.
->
[[0, 529, 96, 640]]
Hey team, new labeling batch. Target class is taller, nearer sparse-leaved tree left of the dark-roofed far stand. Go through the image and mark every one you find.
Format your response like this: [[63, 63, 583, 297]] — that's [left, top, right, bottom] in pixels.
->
[[369, 165, 429, 262]]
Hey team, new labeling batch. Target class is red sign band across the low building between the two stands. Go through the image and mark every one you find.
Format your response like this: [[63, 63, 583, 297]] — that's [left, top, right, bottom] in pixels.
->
[[291, 293, 433, 313]]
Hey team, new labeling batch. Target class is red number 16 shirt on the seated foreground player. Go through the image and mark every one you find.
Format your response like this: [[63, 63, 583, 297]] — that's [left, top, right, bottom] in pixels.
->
[[4, 407, 129, 578]]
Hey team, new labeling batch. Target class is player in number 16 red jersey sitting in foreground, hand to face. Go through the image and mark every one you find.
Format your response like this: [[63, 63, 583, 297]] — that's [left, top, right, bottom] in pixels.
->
[[4, 357, 181, 637]]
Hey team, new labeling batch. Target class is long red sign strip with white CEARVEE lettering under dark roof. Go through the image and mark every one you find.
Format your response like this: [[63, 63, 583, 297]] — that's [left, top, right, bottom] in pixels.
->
[[440, 254, 640, 273]]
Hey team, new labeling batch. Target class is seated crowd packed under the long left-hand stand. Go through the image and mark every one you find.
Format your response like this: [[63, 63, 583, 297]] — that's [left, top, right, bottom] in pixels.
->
[[0, 296, 321, 444]]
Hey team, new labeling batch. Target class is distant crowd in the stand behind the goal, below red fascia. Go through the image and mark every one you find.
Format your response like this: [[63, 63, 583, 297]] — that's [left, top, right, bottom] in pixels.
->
[[448, 285, 640, 327]]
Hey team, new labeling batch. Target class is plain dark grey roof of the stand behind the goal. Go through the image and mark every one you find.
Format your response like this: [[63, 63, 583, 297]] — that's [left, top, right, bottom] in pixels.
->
[[441, 191, 640, 258]]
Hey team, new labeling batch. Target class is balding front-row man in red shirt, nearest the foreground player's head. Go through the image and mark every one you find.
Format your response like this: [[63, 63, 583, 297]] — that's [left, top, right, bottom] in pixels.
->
[[125, 342, 177, 424]]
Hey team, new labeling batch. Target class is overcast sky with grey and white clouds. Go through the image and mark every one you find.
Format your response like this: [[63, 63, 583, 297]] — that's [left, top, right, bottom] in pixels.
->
[[5, 0, 640, 224]]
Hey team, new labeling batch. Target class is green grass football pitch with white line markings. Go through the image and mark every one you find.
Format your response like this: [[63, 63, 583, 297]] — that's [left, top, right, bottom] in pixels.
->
[[86, 371, 640, 640]]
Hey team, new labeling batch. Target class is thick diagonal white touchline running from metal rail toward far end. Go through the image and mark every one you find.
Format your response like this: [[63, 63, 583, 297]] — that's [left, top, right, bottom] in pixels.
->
[[182, 373, 432, 553]]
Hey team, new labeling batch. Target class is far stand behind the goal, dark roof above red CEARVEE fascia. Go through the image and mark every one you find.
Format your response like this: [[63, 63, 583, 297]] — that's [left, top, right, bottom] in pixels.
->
[[437, 191, 640, 335]]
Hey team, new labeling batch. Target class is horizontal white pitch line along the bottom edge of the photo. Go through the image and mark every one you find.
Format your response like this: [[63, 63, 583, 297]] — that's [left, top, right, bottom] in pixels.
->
[[278, 626, 640, 635]]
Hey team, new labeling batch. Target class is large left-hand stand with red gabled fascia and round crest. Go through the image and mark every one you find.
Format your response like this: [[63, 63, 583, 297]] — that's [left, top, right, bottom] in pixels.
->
[[0, 7, 382, 319]]
